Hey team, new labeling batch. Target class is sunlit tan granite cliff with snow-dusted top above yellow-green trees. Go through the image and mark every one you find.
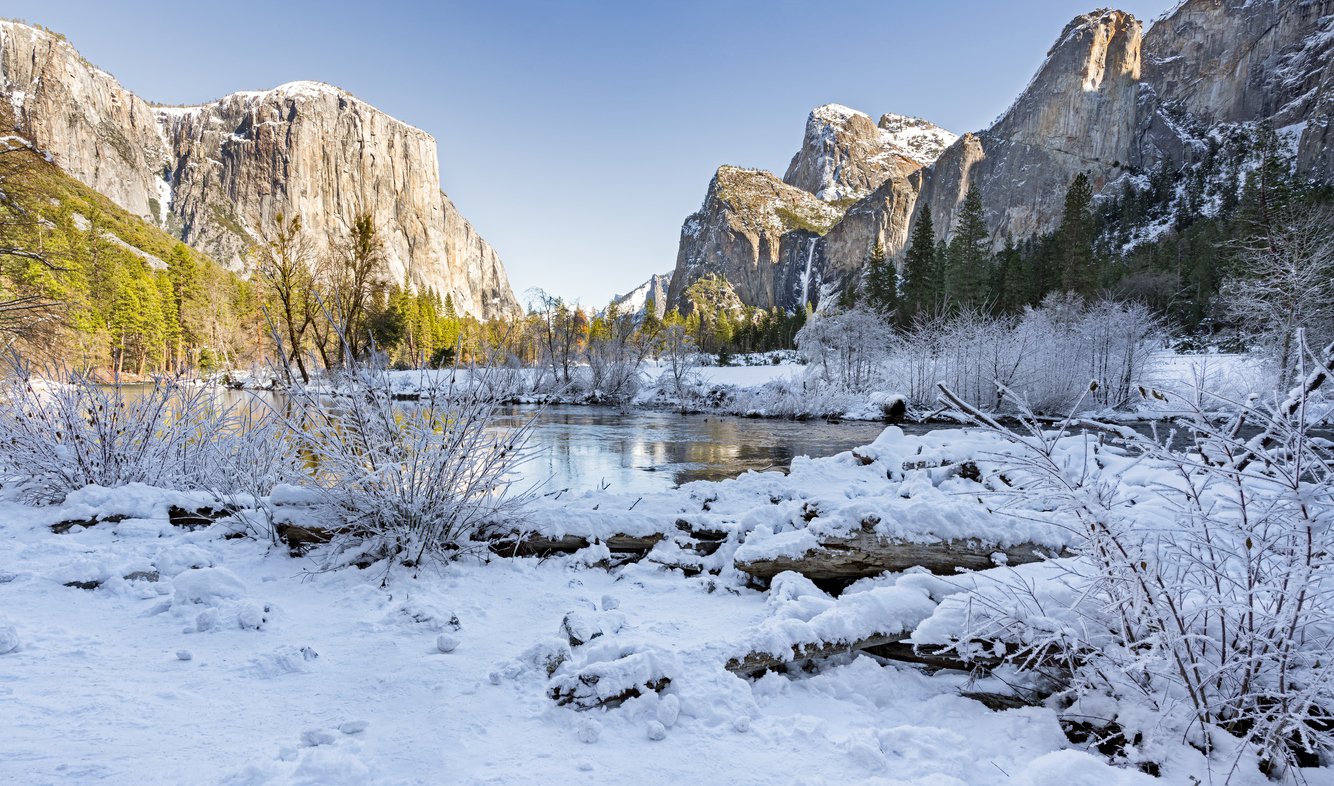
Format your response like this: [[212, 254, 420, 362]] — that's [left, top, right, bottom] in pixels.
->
[[0, 21, 519, 316]]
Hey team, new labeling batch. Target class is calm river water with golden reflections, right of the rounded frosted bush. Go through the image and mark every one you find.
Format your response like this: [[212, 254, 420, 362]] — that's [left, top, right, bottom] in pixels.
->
[[488, 406, 907, 494]]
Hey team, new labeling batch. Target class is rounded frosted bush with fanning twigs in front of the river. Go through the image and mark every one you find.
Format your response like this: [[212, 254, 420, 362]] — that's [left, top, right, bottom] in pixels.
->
[[281, 362, 532, 563]]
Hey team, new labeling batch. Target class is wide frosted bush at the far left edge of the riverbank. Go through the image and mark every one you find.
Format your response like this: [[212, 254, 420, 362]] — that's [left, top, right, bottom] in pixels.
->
[[0, 355, 232, 503]]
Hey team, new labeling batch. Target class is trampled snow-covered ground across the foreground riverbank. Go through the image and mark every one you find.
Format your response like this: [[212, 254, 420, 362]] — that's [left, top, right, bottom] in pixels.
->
[[0, 428, 1331, 786]]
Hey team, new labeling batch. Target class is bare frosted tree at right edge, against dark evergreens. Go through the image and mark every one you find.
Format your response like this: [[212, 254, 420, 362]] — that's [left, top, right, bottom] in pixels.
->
[[1222, 207, 1334, 386]]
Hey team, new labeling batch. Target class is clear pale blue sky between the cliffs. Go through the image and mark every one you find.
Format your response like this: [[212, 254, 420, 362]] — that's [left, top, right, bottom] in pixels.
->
[[15, 0, 1173, 306]]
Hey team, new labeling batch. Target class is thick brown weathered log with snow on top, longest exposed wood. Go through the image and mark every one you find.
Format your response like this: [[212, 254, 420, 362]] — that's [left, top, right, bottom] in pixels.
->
[[735, 530, 1061, 580]]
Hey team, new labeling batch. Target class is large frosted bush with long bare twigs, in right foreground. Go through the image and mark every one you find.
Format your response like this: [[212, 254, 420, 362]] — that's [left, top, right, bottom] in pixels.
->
[[943, 344, 1334, 774]]
